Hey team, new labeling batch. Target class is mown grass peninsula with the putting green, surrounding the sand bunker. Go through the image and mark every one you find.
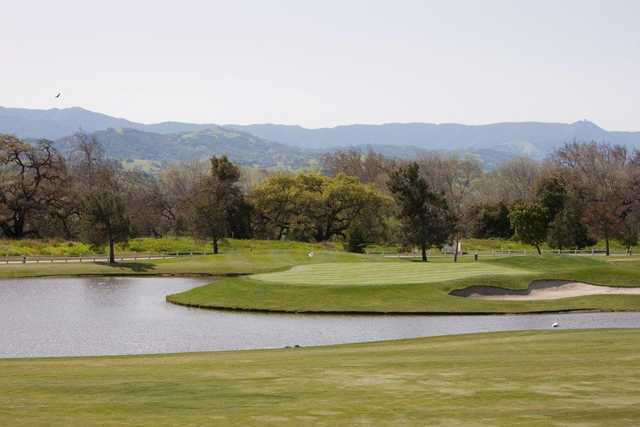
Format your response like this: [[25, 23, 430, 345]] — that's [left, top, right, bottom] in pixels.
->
[[168, 256, 640, 313]]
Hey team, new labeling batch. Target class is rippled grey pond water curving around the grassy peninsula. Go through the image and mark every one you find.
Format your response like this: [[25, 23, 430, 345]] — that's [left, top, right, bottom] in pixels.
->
[[0, 277, 640, 357]]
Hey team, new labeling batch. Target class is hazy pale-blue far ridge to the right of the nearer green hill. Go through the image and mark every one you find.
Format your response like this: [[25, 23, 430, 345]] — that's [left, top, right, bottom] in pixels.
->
[[227, 121, 640, 157]]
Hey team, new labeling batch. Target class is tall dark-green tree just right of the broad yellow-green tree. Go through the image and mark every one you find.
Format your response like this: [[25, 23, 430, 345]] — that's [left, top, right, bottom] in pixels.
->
[[388, 163, 455, 262]]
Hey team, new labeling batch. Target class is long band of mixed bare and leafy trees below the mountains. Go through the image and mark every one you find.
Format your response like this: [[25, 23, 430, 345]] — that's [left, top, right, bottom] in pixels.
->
[[0, 134, 640, 262]]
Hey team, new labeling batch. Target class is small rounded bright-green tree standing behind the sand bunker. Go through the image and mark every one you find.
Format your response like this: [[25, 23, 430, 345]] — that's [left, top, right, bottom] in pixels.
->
[[509, 203, 549, 255]]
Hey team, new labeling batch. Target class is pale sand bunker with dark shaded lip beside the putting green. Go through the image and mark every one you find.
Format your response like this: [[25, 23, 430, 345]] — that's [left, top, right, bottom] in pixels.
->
[[449, 280, 640, 301]]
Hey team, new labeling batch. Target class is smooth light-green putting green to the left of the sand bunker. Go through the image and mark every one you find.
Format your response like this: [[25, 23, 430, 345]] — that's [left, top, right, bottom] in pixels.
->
[[251, 262, 531, 286]]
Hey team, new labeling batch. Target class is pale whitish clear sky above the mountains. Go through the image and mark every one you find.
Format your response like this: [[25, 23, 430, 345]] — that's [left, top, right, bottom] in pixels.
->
[[0, 0, 640, 130]]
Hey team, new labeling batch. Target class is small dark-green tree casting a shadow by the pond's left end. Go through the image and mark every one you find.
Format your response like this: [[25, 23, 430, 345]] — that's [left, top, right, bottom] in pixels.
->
[[81, 191, 131, 264]]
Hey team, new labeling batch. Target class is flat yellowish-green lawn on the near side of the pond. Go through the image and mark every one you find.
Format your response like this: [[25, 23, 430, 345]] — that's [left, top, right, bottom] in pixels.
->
[[0, 329, 640, 426]]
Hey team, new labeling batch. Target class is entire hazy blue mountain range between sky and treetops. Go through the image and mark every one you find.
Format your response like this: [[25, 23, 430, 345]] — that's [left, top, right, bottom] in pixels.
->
[[0, 107, 640, 168]]
